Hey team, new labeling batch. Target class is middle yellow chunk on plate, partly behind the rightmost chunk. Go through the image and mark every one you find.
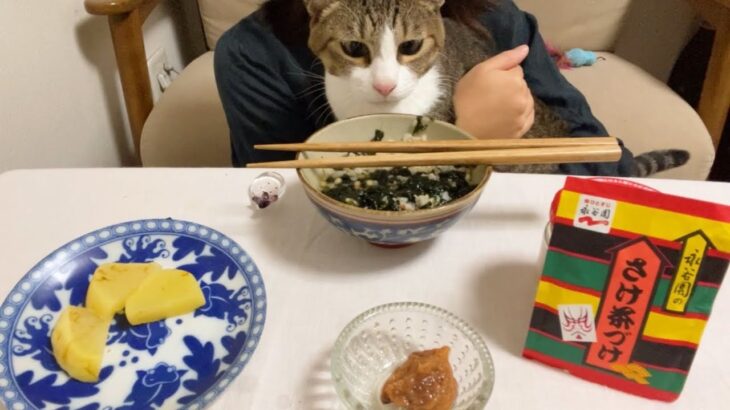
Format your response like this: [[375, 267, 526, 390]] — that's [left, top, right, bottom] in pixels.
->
[[86, 263, 162, 319]]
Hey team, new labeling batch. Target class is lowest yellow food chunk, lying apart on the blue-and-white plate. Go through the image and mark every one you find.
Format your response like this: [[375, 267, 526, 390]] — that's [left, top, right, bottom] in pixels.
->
[[51, 306, 110, 383]]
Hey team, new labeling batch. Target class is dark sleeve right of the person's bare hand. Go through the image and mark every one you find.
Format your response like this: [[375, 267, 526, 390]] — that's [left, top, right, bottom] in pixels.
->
[[482, 0, 633, 176]]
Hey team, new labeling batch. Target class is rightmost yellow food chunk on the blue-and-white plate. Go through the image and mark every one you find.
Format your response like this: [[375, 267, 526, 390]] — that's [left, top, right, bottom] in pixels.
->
[[124, 269, 205, 325]]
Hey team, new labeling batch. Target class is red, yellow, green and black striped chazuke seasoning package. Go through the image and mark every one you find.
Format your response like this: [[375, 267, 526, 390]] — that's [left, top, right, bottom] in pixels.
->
[[523, 177, 730, 401]]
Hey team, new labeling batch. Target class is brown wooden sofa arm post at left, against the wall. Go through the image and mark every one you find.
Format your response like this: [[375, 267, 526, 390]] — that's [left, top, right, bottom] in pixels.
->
[[84, 0, 160, 161]]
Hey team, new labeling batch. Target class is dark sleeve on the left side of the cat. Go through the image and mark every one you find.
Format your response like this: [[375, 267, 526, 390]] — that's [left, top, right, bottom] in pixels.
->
[[214, 15, 315, 167]]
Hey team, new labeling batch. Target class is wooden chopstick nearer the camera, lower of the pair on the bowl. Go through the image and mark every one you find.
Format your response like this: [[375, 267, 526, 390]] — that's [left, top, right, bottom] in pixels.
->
[[248, 144, 621, 168]]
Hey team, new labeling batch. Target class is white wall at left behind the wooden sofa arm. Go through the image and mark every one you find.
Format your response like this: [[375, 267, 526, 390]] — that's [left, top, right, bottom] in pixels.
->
[[0, 0, 204, 172]]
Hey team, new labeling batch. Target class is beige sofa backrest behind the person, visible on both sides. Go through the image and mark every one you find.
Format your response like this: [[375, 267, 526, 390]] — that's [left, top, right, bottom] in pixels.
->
[[198, 0, 697, 81]]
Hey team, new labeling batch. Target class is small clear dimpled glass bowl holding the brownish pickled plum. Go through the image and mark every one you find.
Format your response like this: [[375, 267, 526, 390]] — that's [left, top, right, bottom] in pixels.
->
[[331, 302, 494, 410]]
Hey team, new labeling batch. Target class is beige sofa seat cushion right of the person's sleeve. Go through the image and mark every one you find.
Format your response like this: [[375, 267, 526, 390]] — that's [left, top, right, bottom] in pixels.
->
[[563, 53, 715, 179]]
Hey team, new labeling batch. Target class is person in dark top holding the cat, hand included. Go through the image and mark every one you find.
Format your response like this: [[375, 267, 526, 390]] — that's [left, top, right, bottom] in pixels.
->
[[215, 0, 635, 176]]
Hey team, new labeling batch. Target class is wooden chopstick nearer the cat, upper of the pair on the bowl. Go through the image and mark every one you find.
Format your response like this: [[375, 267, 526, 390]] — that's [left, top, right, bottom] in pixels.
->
[[254, 137, 617, 152]]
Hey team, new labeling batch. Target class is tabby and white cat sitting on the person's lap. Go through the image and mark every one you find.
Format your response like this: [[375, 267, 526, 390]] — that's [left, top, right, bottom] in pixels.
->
[[304, 0, 689, 176]]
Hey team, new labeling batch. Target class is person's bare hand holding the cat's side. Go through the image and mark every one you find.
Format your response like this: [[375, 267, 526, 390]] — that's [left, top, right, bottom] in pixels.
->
[[454, 46, 535, 139]]
